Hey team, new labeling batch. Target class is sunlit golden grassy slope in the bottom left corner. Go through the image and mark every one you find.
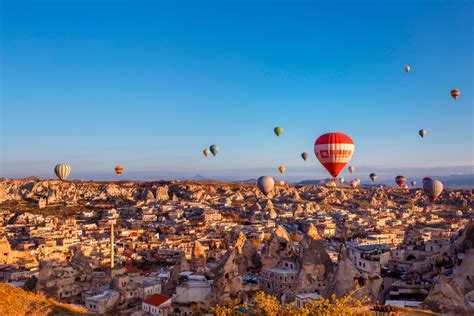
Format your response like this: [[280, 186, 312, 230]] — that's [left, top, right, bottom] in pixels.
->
[[0, 283, 86, 316]]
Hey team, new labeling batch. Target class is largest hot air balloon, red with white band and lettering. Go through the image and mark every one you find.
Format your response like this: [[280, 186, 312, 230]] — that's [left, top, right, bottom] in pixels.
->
[[314, 133, 354, 179]]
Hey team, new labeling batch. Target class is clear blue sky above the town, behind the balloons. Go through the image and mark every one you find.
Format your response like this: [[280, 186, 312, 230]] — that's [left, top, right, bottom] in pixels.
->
[[0, 0, 474, 180]]
